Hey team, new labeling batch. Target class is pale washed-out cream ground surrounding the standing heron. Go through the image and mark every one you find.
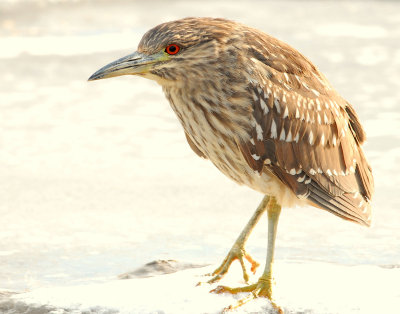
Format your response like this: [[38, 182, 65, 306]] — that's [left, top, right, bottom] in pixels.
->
[[0, 1, 400, 313]]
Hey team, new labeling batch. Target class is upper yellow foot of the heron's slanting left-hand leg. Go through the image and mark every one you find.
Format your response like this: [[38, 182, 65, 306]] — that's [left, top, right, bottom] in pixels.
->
[[207, 243, 260, 284]]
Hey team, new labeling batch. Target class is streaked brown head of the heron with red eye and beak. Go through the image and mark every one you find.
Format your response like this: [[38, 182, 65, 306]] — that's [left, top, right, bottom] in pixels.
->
[[89, 18, 241, 85]]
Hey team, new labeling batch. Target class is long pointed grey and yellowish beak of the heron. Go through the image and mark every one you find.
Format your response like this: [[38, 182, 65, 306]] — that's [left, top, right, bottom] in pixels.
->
[[88, 52, 162, 81]]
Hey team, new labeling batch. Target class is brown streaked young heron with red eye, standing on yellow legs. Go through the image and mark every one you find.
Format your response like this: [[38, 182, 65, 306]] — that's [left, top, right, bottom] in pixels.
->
[[89, 18, 373, 314]]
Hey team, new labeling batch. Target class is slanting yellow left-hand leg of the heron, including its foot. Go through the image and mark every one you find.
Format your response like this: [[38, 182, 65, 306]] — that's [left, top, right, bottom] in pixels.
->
[[208, 195, 270, 283]]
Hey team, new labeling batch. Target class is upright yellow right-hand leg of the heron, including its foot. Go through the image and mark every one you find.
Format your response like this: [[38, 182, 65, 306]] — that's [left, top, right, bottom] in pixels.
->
[[211, 197, 283, 313]]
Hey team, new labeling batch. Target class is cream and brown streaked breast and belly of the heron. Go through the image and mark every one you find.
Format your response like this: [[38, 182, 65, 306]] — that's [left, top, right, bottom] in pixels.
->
[[163, 87, 295, 205]]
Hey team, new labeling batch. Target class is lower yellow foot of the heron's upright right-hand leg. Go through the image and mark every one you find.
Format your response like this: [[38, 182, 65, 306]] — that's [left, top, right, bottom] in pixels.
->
[[210, 277, 283, 314]]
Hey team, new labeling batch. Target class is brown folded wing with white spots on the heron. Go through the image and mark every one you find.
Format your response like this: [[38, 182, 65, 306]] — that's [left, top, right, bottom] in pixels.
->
[[239, 40, 374, 225]]
